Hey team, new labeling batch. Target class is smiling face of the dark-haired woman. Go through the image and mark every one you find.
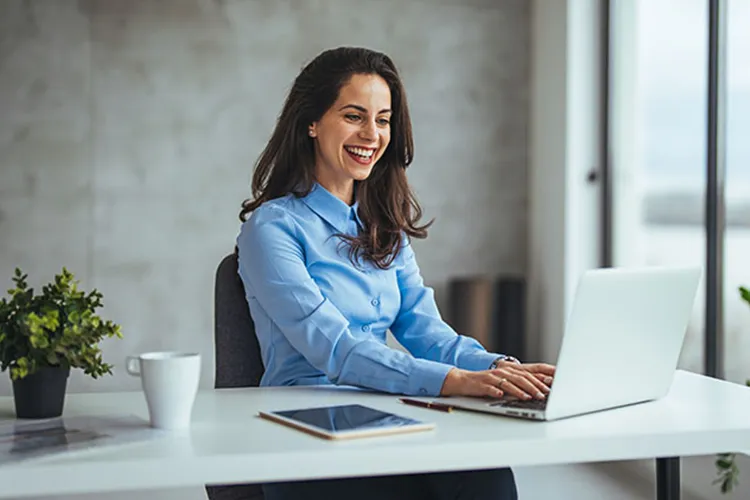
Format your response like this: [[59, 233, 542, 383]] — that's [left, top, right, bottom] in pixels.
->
[[310, 74, 391, 197]]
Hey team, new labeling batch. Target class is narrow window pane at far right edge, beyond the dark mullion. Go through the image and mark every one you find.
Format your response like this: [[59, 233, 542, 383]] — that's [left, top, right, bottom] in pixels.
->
[[724, 0, 750, 382]]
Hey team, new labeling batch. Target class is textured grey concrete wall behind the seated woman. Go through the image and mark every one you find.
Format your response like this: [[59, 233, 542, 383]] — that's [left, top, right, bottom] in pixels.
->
[[0, 0, 530, 394]]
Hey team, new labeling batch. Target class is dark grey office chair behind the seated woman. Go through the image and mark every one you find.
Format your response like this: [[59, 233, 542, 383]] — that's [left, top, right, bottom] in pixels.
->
[[206, 253, 265, 500]]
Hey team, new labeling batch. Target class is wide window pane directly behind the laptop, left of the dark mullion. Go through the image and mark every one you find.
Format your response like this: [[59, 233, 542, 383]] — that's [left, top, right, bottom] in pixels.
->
[[611, 0, 708, 372]]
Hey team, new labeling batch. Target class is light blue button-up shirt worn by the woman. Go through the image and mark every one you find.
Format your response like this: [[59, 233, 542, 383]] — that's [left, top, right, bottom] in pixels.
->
[[237, 184, 500, 396]]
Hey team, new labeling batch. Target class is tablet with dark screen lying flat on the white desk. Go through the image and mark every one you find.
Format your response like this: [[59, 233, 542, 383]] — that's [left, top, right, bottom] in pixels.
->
[[258, 404, 435, 439]]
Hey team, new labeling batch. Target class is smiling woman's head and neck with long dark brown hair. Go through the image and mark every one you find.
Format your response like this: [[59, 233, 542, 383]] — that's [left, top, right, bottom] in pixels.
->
[[240, 47, 429, 268]]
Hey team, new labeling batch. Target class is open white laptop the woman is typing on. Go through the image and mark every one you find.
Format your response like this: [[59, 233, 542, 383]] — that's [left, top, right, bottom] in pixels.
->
[[438, 268, 701, 420]]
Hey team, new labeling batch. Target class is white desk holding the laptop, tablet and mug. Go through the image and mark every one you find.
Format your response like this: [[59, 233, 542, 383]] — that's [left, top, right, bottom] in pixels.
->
[[0, 372, 750, 499]]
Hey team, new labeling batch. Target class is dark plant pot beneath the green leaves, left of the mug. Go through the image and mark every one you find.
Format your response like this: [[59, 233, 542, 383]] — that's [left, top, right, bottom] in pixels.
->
[[13, 366, 70, 418]]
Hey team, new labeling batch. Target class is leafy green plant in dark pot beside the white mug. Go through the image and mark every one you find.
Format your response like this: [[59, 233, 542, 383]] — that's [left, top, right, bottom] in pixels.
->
[[0, 268, 122, 418]]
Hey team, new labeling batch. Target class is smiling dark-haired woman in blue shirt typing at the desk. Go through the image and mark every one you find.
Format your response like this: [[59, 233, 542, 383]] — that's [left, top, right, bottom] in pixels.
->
[[237, 47, 554, 500]]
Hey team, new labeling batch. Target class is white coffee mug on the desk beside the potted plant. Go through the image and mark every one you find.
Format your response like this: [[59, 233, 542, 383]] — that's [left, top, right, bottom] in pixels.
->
[[125, 352, 201, 430]]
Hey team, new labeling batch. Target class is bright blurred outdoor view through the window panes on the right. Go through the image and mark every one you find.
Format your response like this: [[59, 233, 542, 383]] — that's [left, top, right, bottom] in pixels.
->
[[611, 0, 750, 382]]
